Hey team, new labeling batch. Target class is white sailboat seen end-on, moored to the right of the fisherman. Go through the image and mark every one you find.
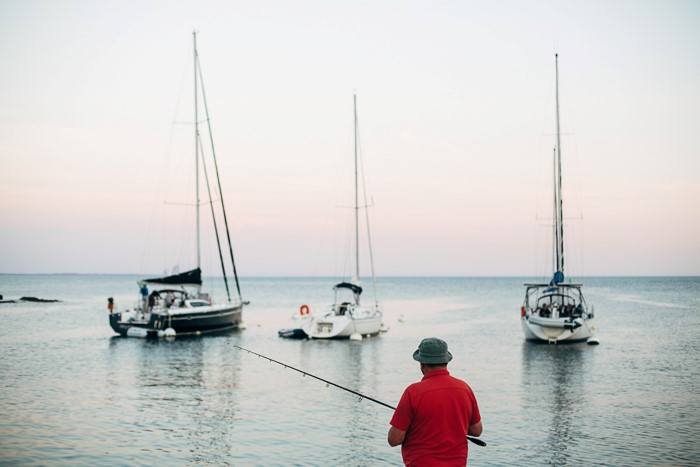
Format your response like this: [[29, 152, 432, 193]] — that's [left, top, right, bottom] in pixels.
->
[[520, 55, 598, 344]]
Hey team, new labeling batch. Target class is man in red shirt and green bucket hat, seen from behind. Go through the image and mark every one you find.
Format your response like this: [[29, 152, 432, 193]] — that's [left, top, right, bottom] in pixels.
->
[[388, 337, 482, 466]]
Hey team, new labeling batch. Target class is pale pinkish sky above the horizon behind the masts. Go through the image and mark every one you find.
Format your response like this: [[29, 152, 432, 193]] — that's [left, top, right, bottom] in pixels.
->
[[0, 0, 700, 276]]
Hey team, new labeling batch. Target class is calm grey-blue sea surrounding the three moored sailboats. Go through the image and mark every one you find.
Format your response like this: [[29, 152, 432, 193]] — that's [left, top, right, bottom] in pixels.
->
[[0, 275, 700, 466]]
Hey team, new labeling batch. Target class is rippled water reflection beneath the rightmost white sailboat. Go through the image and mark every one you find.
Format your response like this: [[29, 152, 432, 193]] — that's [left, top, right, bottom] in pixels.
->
[[522, 341, 590, 465]]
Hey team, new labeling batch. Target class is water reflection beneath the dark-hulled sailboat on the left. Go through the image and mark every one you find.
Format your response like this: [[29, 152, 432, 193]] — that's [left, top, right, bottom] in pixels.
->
[[107, 337, 240, 464]]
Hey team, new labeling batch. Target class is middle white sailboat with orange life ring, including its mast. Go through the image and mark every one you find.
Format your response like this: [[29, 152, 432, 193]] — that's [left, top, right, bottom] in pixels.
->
[[296, 95, 385, 340]]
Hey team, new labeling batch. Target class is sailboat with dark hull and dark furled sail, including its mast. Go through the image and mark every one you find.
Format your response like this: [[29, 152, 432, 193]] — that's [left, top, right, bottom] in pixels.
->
[[108, 32, 248, 337]]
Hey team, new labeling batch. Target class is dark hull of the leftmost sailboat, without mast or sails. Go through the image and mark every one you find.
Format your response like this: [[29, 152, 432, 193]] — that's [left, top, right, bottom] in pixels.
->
[[109, 305, 243, 336]]
